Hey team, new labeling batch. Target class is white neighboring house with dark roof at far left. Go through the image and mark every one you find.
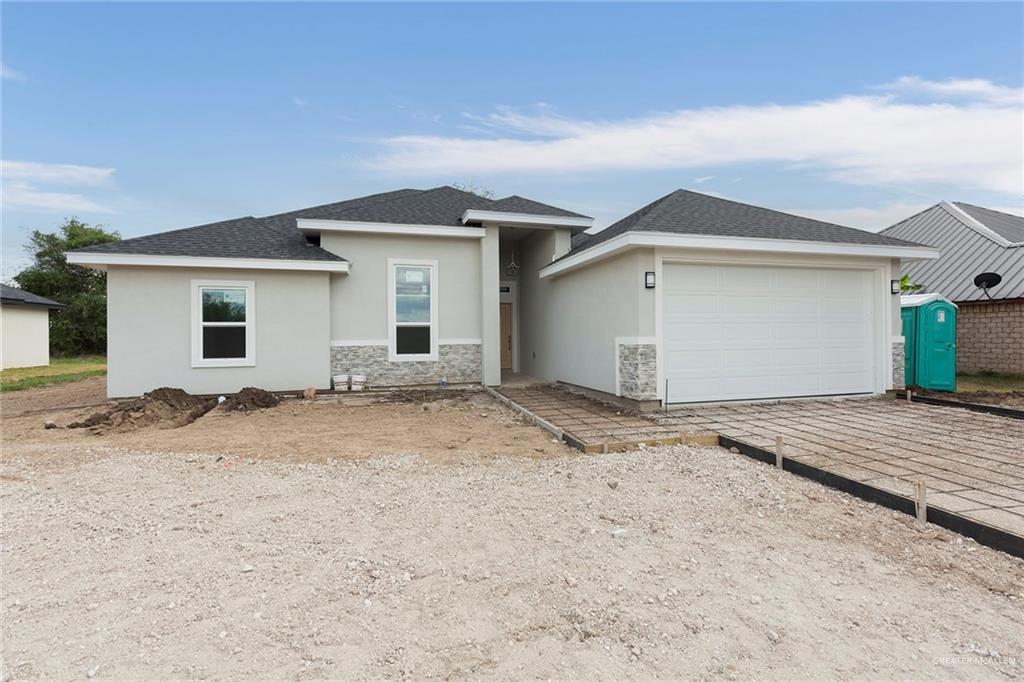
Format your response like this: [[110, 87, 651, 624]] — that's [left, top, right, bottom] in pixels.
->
[[0, 285, 63, 370]]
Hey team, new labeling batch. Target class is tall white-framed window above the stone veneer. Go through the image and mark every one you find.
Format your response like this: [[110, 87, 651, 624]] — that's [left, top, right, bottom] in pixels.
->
[[387, 258, 437, 363]]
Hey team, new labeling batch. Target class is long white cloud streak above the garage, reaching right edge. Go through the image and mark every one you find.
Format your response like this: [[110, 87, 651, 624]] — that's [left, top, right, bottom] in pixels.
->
[[369, 75, 1024, 194]]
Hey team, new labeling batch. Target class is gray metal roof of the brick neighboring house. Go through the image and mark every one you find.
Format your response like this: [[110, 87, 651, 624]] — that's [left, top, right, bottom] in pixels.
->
[[883, 202, 1024, 302]]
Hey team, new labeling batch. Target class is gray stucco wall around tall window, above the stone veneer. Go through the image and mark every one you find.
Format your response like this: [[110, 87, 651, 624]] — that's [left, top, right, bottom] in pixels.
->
[[321, 232, 481, 342]]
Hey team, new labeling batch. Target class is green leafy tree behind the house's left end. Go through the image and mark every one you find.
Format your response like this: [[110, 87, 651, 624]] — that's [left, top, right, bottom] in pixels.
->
[[14, 218, 121, 355]]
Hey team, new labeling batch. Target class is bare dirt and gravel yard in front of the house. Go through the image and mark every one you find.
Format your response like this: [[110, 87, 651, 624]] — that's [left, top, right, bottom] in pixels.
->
[[0, 382, 1024, 680]]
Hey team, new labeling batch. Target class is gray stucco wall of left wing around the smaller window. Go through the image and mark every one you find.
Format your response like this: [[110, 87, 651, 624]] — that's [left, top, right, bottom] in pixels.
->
[[106, 266, 331, 397]]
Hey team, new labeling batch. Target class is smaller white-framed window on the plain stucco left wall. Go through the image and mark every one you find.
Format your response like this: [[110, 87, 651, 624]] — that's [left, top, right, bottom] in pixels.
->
[[191, 280, 256, 367]]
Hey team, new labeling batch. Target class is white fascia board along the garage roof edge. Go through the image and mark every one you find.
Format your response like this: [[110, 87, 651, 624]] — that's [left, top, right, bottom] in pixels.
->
[[540, 232, 939, 279]]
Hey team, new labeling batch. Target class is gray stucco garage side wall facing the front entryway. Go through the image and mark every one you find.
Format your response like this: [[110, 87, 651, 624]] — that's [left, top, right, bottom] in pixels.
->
[[519, 232, 654, 394]]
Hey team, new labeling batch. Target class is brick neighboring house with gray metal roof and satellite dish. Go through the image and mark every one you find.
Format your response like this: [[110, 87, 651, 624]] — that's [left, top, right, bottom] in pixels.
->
[[882, 202, 1024, 374]]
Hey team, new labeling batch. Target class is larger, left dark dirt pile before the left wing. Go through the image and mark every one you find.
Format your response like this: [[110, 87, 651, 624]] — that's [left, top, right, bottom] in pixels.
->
[[68, 387, 217, 433]]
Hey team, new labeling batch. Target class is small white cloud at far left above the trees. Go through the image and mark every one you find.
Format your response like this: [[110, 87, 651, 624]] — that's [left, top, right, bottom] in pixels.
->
[[0, 161, 115, 213]]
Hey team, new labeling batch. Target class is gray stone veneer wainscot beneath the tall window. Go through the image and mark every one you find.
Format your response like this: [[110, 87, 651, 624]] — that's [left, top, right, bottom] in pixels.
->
[[331, 343, 482, 386]]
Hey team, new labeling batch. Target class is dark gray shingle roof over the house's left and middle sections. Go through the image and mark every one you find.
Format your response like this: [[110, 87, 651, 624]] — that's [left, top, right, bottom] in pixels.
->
[[72, 186, 587, 261]]
